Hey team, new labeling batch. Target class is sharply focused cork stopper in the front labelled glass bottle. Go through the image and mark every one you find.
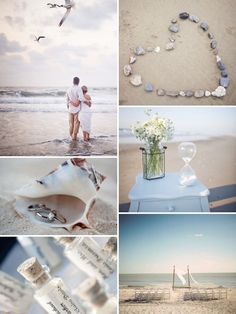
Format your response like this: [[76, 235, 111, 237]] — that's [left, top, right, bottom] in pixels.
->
[[17, 257, 50, 286]]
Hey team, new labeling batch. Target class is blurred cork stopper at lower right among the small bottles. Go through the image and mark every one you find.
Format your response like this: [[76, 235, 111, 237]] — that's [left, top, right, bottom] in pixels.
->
[[78, 277, 108, 307]]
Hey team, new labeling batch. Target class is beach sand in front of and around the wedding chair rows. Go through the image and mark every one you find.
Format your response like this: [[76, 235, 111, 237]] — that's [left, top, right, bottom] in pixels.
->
[[119, 287, 236, 314]]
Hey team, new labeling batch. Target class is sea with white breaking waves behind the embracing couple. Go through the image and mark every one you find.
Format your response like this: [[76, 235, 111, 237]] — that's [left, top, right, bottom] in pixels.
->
[[0, 87, 117, 113]]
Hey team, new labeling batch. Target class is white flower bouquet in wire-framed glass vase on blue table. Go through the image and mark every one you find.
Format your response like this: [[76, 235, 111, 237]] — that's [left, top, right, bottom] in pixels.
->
[[132, 110, 174, 179]]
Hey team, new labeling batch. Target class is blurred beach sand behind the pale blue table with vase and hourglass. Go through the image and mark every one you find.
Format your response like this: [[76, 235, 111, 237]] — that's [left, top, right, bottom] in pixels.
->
[[119, 137, 236, 207]]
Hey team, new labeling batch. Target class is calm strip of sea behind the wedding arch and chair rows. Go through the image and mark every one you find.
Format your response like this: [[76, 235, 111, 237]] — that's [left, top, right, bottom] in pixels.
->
[[120, 273, 236, 288]]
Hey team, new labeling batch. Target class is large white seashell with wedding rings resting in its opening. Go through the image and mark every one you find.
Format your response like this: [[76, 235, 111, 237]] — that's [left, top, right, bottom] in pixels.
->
[[15, 158, 106, 228]]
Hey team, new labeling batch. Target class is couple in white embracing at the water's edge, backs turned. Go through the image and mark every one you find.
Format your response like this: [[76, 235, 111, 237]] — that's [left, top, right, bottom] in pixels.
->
[[66, 77, 92, 142]]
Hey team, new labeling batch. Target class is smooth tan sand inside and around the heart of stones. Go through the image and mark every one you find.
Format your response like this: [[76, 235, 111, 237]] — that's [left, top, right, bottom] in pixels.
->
[[119, 0, 236, 105]]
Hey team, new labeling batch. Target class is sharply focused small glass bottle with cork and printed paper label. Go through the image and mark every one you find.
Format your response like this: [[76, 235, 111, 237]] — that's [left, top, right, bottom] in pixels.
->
[[17, 257, 86, 314]]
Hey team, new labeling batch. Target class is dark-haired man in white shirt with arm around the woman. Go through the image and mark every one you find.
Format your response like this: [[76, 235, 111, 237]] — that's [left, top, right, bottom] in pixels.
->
[[66, 77, 85, 140]]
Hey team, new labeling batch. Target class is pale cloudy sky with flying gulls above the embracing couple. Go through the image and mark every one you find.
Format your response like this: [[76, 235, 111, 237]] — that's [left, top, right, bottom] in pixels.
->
[[0, 0, 117, 87]]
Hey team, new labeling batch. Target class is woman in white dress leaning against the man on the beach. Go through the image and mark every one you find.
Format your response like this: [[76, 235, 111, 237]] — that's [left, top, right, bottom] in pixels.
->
[[79, 86, 92, 142]]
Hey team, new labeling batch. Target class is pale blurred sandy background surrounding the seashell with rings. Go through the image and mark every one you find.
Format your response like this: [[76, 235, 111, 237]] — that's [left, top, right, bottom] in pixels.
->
[[0, 158, 117, 235]]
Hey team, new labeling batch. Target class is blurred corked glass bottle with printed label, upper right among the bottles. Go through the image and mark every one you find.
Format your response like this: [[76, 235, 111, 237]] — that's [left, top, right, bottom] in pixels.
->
[[57, 237, 115, 279]]
